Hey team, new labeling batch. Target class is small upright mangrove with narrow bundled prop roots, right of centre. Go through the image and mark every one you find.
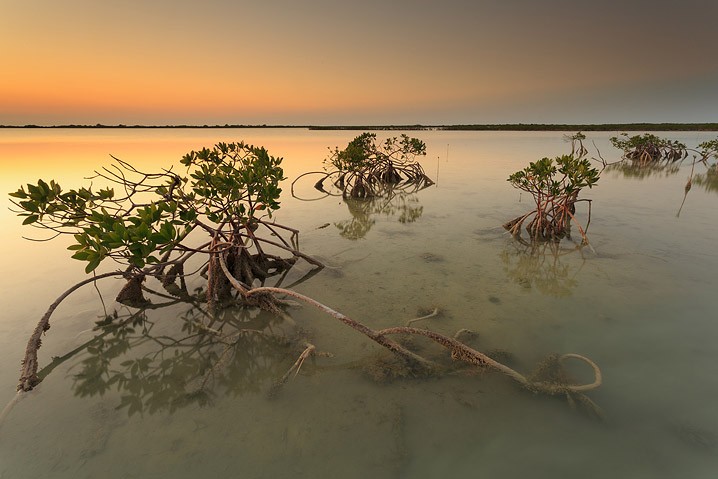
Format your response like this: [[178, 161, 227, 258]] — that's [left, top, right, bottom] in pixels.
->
[[503, 149, 600, 244]]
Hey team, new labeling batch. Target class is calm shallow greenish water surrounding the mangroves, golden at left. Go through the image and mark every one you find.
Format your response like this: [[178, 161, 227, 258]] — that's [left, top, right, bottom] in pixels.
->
[[0, 129, 718, 479]]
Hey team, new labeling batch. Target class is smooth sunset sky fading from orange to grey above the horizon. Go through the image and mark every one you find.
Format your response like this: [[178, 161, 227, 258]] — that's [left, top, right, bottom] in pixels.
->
[[0, 0, 718, 125]]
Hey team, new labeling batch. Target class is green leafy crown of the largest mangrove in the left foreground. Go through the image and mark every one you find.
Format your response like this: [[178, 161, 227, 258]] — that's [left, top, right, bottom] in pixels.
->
[[10, 143, 284, 273]]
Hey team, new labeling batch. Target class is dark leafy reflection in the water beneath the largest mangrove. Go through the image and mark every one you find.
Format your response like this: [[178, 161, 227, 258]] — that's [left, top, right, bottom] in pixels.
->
[[65, 298, 299, 416]]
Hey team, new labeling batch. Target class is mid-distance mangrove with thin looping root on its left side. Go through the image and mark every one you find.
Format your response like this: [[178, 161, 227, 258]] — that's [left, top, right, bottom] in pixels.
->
[[292, 133, 434, 198]]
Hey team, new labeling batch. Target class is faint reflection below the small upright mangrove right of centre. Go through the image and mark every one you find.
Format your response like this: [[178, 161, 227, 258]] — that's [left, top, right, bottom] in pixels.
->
[[500, 241, 585, 297]]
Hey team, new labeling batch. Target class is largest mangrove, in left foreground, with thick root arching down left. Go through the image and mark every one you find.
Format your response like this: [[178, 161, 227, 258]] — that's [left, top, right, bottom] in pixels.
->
[[10, 143, 321, 391]]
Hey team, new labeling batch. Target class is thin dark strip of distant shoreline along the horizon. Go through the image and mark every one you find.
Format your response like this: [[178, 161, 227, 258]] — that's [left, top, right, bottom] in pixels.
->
[[0, 123, 718, 131]]
